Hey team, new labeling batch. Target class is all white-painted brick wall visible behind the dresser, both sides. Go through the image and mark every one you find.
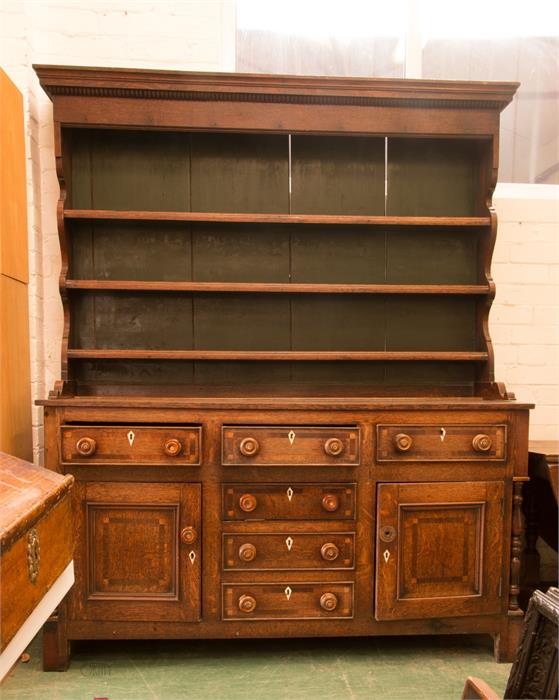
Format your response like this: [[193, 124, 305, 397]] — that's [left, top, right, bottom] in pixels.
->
[[0, 0, 559, 462]]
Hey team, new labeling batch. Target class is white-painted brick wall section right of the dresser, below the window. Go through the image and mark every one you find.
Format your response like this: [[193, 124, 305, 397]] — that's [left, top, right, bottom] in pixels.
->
[[489, 184, 559, 440]]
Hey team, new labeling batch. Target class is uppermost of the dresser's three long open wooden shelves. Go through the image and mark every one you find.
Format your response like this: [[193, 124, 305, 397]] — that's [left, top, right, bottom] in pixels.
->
[[64, 209, 491, 228]]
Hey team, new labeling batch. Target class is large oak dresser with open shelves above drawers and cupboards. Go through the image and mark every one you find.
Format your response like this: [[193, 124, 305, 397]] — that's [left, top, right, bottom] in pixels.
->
[[37, 66, 529, 668]]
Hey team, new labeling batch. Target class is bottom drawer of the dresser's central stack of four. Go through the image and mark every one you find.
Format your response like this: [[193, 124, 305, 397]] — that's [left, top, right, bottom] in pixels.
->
[[223, 582, 353, 620]]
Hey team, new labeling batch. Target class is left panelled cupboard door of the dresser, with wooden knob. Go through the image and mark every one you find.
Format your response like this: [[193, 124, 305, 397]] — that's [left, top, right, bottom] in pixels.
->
[[74, 482, 201, 621]]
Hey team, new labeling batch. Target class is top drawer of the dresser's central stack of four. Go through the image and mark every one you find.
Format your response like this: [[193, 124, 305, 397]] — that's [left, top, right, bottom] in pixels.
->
[[221, 425, 359, 467]]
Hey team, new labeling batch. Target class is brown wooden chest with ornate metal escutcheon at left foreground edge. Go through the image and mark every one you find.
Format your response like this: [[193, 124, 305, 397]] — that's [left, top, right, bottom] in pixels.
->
[[0, 453, 74, 676]]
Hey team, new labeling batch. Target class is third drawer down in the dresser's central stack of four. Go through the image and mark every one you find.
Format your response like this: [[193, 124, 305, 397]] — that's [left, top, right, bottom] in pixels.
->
[[223, 532, 355, 571]]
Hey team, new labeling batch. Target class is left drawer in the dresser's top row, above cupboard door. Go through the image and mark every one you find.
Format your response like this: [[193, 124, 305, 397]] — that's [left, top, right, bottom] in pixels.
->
[[61, 425, 201, 466]]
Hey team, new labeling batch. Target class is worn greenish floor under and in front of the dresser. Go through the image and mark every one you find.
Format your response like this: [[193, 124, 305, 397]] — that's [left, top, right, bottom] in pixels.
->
[[0, 636, 510, 700]]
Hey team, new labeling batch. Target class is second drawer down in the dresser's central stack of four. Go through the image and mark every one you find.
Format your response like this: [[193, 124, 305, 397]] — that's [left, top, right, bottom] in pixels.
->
[[223, 484, 355, 520]]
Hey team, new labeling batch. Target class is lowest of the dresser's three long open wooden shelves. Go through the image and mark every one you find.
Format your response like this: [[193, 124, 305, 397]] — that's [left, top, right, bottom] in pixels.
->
[[68, 349, 488, 362]]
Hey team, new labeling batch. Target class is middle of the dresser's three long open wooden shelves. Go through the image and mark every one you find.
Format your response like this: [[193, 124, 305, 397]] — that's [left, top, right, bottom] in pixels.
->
[[66, 279, 489, 295]]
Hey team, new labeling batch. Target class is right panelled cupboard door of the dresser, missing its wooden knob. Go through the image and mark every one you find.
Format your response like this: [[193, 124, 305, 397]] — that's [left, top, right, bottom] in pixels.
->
[[375, 481, 503, 620]]
